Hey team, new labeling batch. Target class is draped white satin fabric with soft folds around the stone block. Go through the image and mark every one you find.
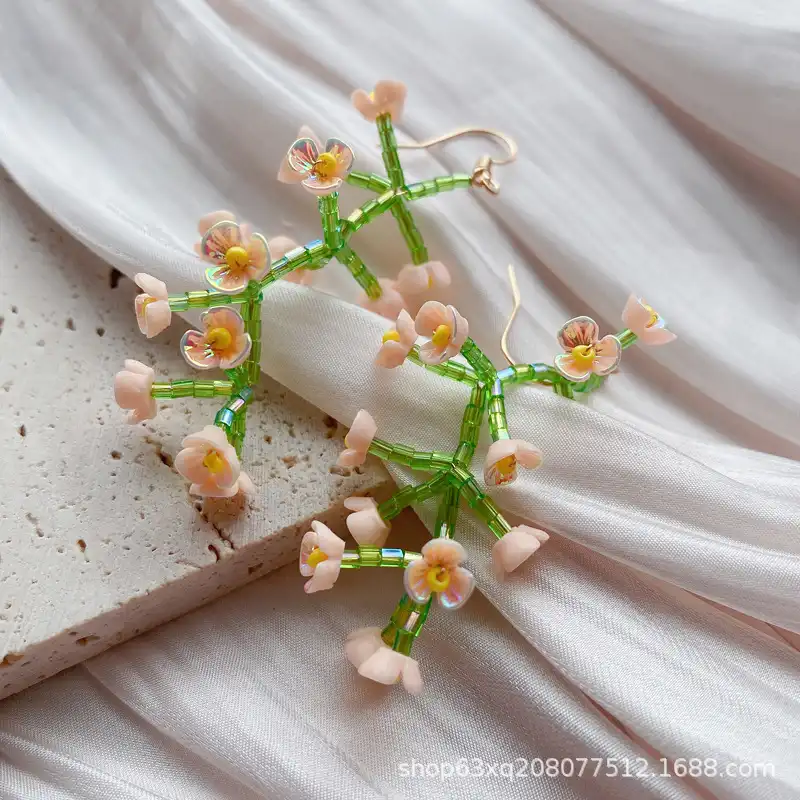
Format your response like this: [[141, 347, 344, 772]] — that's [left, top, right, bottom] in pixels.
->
[[0, 0, 800, 800]]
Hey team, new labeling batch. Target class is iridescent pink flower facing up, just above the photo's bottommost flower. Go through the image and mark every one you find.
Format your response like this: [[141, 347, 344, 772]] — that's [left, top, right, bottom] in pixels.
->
[[403, 539, 475, 608]]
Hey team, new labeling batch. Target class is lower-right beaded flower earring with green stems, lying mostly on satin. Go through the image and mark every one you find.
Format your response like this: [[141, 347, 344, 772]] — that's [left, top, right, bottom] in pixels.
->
[[300, 276, 676, 694]]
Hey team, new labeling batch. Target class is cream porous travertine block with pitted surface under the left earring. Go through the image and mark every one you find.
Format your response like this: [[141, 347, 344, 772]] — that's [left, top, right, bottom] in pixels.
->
[[0, 176, 391, 697]]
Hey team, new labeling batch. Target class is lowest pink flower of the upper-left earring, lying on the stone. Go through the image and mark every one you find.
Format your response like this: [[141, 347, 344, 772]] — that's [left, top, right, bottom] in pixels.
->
[[175, 425, 253, 497]]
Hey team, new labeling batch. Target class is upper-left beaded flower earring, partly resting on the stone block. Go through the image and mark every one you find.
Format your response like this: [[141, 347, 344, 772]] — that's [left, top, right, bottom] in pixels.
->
[[114, 81, 516, 497]]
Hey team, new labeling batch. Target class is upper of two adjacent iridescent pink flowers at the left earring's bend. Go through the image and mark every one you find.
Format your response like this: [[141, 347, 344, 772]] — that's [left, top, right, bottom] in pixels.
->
[[195, 211, 272, 294]]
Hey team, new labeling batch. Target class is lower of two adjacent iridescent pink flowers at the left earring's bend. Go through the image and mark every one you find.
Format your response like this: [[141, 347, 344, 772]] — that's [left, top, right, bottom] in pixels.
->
[[180, 306, 252, 369]]
